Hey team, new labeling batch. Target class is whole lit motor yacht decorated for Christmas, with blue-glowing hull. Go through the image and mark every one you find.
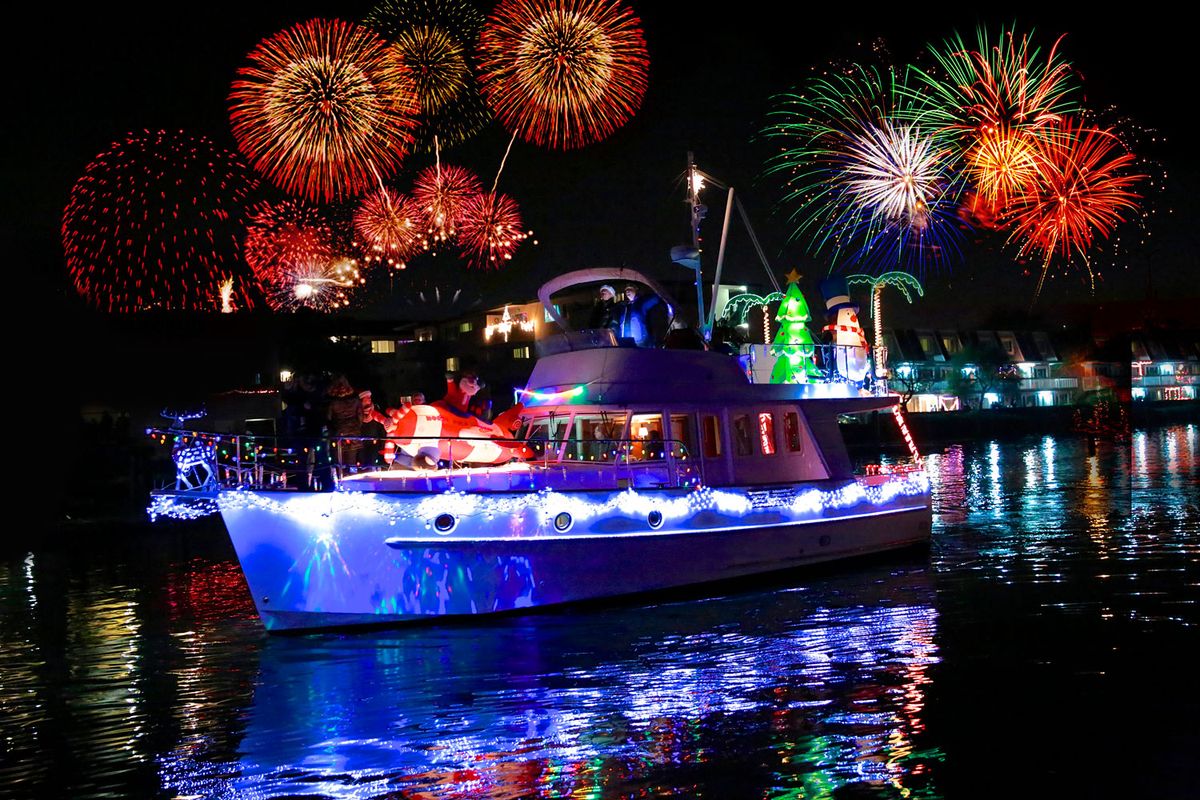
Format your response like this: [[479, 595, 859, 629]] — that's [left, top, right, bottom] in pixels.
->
[[151, 269, 931, 631]]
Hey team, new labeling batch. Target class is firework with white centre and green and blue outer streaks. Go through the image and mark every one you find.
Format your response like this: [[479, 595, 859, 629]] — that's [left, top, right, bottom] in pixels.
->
[[764, 67, 962, 270]]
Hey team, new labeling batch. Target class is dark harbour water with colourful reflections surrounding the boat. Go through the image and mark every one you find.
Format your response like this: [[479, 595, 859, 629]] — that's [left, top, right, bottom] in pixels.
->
[[0, 425, 1200, 799]]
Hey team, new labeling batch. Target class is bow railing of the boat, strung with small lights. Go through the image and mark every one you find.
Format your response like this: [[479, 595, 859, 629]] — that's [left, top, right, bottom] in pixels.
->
[[146, 428, 703, 494]]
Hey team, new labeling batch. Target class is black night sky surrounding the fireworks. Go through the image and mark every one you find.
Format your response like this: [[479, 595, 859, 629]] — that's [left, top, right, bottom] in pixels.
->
[[5, 2, 1200, 388]]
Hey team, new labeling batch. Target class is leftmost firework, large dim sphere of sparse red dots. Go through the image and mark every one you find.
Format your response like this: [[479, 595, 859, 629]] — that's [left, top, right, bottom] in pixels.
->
[[62, 131, 257, 312]]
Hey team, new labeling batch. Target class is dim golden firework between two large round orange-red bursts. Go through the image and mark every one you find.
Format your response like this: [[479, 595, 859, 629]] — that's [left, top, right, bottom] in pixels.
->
[[366, 0, 491, 150]]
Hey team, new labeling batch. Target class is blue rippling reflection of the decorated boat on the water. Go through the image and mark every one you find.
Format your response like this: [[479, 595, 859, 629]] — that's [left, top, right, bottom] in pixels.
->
[[154, 587, 936, 798]]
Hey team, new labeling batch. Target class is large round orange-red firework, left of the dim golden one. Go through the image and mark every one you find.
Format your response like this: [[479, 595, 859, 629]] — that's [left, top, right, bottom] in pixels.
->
[[229, 19, 418, 201]]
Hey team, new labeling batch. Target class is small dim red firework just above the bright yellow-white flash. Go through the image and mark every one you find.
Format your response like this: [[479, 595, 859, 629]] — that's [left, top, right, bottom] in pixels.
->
[[246, 200, 335, 285]]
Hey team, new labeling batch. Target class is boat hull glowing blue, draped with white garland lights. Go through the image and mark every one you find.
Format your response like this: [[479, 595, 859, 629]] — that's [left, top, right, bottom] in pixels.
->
[[220, 473, 931, 631]]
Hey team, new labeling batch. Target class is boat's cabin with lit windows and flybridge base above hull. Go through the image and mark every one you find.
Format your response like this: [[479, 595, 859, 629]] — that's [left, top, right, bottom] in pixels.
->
[[520, 333, 893, 487]]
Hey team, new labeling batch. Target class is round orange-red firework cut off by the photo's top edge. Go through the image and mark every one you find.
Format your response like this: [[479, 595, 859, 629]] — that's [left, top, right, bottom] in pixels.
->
[[479, 0, 649, 150]]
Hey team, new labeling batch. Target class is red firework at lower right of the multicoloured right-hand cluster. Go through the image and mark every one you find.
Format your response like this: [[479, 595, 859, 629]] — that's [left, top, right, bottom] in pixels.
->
[[1009, 120, 1142, 293]]
